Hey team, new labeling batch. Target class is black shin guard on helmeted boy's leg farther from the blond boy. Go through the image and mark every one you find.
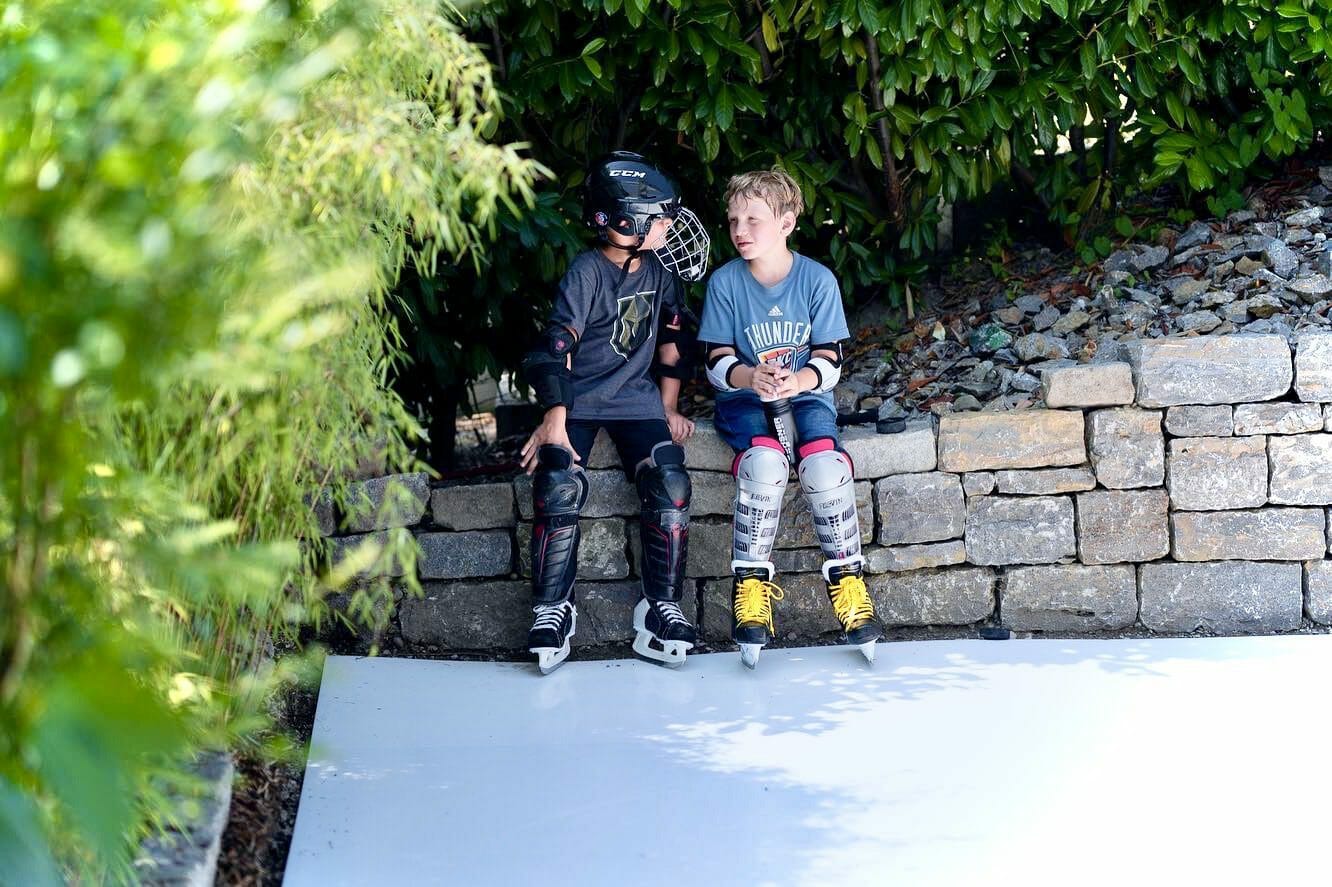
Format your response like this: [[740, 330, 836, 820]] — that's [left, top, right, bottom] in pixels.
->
[[531, 444, 587, 603]]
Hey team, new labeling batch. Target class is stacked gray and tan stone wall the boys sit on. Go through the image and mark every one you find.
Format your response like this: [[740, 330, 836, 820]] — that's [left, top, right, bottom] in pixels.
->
[[318, 332, 1332, 650]]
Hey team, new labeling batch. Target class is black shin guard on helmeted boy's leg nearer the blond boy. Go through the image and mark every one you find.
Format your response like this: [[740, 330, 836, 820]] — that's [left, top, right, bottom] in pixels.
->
[[637, 442, 693, 602]]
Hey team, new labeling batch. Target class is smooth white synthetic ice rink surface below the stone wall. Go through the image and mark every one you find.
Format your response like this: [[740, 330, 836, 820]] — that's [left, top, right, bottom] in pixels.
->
[[285, 635, 1332, 887]]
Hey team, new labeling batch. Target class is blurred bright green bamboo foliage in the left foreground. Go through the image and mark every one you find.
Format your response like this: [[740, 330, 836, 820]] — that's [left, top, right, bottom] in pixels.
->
[[0, 0, 541, 884]]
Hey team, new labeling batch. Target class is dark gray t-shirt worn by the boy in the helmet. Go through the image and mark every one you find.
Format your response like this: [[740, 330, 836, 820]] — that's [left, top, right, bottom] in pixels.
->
[[550, 249, 679, 420]]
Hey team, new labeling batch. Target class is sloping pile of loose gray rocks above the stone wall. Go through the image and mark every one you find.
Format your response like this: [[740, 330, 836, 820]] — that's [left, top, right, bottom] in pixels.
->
[[836, 166, 1332, 430]]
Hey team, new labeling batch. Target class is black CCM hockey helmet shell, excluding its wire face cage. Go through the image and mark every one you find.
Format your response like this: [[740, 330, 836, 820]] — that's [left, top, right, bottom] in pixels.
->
[[583, 150, 681, 238]]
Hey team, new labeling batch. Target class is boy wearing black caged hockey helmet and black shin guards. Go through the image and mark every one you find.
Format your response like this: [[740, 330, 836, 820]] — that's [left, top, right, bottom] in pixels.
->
[[522, 152, 707, 674]]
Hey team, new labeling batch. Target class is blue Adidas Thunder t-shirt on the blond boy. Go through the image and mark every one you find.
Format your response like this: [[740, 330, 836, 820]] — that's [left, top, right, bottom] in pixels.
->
[[698, 253, 850, 412]]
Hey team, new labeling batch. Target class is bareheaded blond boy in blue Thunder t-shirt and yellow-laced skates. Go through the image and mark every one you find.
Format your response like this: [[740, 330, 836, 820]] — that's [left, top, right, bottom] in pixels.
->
[[698, 168, 883, 669]]
